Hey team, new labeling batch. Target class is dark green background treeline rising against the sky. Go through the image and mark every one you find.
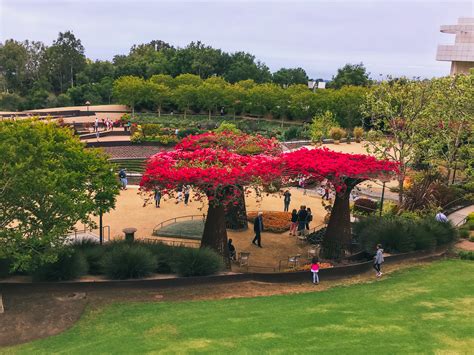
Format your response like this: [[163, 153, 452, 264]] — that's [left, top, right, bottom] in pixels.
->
[[0, 31, 369, 117]]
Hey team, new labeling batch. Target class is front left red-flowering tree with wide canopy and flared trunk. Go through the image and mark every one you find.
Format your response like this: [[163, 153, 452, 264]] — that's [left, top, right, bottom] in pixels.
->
[[140, 148, 281, 268]]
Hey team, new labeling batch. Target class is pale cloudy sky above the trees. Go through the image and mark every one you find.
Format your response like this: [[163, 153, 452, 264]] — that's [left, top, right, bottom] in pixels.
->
[[0, 0, 474, 79]]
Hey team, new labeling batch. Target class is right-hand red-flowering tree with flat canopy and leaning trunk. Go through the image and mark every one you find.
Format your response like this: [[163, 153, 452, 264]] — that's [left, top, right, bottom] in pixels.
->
[[282, 149, 398, 259]]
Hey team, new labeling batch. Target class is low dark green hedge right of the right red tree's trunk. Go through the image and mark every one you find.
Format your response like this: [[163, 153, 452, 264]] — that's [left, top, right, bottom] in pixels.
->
[[353, 216, 457, 253]]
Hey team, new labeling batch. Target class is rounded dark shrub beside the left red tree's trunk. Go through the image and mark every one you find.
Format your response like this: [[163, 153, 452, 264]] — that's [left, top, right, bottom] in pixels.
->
[[176, 248, 223, 276]]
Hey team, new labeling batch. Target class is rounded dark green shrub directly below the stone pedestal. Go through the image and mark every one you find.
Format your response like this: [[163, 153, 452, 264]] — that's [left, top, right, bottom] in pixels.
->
[[101, 242, 156, 279]]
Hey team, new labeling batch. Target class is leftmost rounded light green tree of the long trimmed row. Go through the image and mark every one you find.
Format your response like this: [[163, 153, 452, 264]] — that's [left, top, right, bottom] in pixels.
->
[[113, 76, 146, 116]]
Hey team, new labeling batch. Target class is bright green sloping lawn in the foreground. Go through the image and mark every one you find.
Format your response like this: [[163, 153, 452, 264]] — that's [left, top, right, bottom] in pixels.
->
[[4, 260, 474, 354]]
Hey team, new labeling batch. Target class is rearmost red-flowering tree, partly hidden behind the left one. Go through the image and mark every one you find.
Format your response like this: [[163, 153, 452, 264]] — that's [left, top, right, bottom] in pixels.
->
[[176, 131, 282, 230]]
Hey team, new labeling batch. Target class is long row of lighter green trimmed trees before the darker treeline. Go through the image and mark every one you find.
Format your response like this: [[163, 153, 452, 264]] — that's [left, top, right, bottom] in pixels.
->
[[113, 74, 368, 127]]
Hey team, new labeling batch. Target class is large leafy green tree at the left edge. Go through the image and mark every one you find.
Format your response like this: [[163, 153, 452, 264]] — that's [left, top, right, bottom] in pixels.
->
[[0, 120, 119, 271]]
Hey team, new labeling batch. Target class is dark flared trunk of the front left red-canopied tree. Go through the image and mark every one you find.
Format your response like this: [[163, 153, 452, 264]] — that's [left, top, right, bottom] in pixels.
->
[[201, 204, 230, 269]]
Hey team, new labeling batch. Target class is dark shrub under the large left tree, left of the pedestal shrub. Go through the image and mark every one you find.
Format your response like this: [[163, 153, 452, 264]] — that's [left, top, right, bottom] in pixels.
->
[[32, 250, 87, 281]]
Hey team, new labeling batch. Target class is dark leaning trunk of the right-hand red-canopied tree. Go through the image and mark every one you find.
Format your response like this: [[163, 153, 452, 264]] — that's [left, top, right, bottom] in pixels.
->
[[321, 179, 360, 259]]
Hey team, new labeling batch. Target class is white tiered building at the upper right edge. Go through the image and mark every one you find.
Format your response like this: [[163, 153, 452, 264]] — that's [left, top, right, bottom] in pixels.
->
[[436, 17, 474, 75]]
